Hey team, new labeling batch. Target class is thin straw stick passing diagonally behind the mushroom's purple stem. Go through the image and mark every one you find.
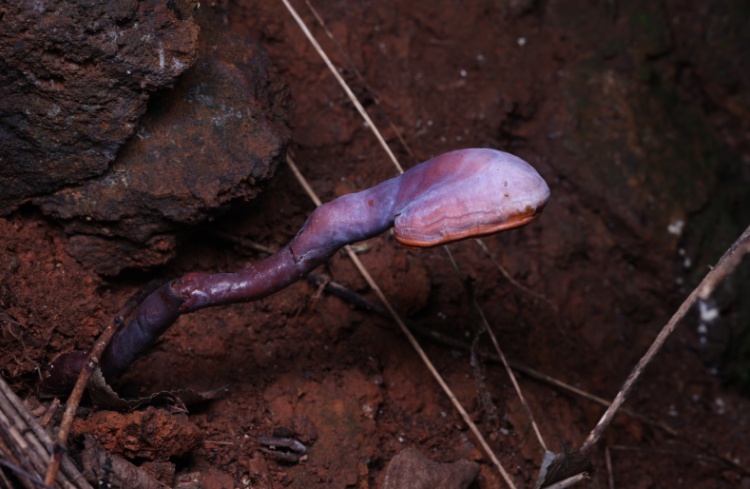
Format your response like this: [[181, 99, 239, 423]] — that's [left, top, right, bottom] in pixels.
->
[[286, 155, 516, 489]]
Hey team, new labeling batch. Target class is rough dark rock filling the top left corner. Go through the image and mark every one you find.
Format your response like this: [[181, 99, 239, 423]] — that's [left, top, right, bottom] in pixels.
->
[[0, 0, 198, 214]]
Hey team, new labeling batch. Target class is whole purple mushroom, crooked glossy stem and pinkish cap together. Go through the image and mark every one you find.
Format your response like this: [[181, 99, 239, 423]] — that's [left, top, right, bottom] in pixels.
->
[[43, 149, 549, 393]]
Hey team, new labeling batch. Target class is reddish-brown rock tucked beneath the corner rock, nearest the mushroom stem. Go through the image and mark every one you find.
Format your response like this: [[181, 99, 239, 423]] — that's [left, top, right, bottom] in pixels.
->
[[34, 9, 288, 275]]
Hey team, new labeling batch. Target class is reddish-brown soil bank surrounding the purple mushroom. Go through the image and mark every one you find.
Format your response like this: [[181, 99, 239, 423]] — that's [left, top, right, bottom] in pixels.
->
[[0, 2, 750, 489]]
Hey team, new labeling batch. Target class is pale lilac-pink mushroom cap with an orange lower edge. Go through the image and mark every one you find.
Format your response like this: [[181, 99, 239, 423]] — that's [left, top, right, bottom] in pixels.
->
[[393, 148, 550, 248]]
